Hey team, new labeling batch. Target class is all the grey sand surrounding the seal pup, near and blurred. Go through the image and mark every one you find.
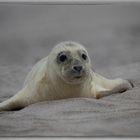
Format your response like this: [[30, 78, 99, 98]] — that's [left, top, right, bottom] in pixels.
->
[[0, 4, 140, 137]]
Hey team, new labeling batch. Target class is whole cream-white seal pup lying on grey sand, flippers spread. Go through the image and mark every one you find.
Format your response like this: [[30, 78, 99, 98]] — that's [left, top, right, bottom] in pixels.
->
[[0, 42, 132, 111]]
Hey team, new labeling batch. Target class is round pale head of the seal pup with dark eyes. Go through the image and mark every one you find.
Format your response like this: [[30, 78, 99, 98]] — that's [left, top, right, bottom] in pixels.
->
[[49, 41, 91, 84]]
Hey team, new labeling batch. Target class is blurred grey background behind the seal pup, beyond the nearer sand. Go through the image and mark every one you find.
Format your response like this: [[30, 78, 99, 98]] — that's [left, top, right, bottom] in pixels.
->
[[0, 3, 140, 69]]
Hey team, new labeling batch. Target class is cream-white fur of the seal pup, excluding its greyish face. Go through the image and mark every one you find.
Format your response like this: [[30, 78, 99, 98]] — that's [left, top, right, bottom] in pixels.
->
[[0, 42, 132, 111]]
